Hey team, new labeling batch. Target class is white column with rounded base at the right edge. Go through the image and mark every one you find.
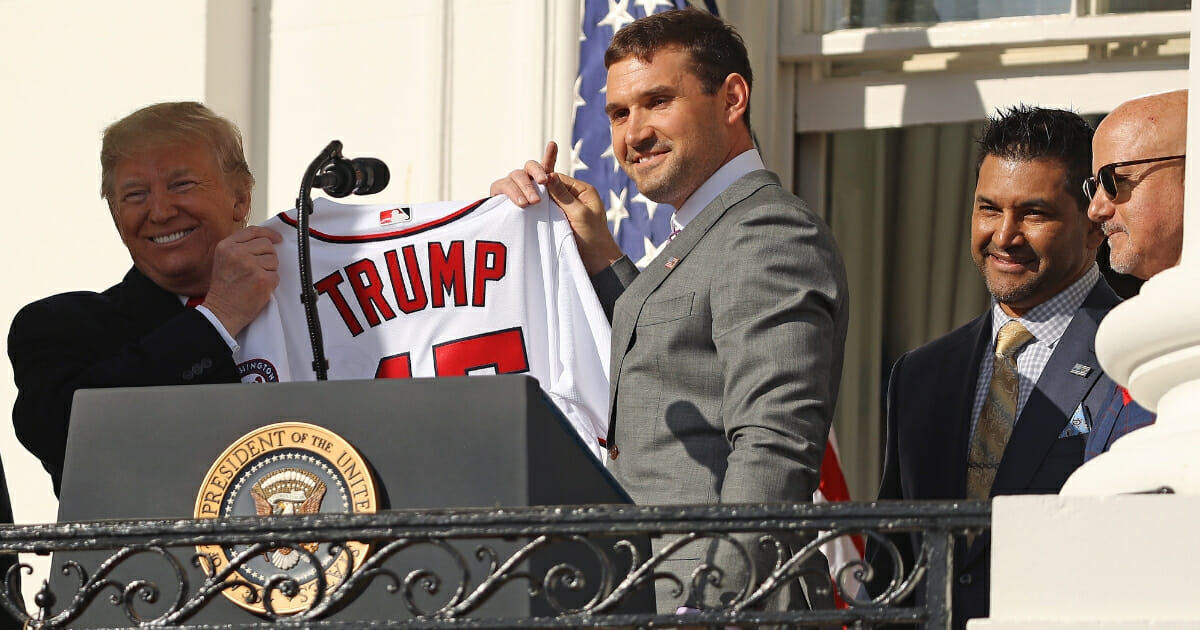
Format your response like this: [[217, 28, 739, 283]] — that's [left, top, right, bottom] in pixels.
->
[[1062, 3, 1200, 496]]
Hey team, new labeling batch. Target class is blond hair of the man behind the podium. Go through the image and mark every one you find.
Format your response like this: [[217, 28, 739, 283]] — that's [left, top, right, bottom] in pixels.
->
[[100, 101, 254, 211]]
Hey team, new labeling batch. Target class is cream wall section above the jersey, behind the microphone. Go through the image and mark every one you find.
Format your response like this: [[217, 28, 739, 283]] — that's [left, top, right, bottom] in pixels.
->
[[259, 0, 575, 212]]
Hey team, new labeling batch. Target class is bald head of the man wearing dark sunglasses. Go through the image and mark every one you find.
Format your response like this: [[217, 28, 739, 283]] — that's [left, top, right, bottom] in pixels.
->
[[1087, 90, 1188, 280]]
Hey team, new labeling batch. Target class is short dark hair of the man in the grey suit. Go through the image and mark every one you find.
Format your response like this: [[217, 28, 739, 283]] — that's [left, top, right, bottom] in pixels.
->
[[604, 7, 754, 130]]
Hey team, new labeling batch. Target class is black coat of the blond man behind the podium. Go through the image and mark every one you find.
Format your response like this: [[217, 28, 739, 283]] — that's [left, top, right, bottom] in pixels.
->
[[8, 269, 238, 494]]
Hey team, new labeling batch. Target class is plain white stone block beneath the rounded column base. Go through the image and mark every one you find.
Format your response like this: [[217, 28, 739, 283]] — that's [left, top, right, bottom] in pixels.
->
[[967, 494, 1200, 630]]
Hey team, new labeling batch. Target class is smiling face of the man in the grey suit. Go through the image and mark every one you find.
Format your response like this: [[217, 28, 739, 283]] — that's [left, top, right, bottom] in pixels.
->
[[605, 46, 752, 208]]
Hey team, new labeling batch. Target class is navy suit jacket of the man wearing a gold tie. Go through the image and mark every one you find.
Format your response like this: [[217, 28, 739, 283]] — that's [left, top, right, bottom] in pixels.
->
[[868, 277, 1142, 628]]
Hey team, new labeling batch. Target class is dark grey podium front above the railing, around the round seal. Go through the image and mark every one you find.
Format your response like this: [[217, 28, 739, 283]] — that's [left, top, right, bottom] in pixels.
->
[[59, 376, 631, 521]]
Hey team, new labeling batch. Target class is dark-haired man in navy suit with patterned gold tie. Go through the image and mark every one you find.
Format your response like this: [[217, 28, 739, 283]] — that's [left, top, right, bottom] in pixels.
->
[[868, 106, 1148, 628]]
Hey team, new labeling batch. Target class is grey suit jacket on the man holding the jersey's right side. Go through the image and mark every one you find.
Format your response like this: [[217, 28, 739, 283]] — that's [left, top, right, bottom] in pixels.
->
[[594, 170, 847, 607]]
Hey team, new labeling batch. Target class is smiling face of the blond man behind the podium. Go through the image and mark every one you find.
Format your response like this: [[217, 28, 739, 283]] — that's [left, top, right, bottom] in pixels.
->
[[112, 142, 250, 295]]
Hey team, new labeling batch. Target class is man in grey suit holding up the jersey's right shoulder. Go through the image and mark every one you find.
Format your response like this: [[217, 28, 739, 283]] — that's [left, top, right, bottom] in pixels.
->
[[492, 10, 847, 611]]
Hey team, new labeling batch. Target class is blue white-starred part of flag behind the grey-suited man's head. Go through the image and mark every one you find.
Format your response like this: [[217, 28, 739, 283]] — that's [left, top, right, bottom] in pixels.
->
[[569, 0, 700, 266]]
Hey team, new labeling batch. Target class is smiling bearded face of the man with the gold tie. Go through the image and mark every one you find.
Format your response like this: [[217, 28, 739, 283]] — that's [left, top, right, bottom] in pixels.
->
[[971, 155, 1104, 316]]
